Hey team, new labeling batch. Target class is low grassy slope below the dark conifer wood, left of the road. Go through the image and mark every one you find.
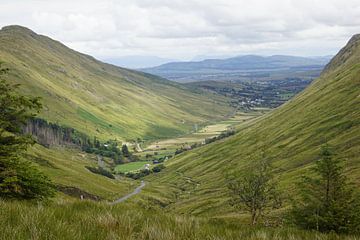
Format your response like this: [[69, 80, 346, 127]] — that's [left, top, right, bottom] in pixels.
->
[[28, 145, 132, 200]]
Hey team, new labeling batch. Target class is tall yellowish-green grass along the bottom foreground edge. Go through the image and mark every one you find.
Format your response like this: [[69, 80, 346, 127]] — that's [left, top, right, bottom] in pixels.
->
[[0, 200, 358, 240]]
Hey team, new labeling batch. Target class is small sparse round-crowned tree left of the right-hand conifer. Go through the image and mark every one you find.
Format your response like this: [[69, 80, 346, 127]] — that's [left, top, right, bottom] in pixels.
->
[[228, 156, 281, 225]]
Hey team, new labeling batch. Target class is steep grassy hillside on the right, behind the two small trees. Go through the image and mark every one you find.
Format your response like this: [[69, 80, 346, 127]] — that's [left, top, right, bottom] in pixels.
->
[[147, 35, 360, 215]]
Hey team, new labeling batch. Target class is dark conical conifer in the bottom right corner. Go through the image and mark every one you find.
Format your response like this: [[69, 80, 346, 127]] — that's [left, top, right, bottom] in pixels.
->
[[290, 145, 360, 233]]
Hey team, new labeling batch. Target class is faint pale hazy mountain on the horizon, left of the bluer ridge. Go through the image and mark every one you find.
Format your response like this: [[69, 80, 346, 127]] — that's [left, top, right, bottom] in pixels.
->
[[102, 56, 175, 69]]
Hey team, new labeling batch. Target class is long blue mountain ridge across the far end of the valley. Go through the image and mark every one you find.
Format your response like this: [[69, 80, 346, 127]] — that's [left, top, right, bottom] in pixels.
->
[[141, 55, 330, 82]]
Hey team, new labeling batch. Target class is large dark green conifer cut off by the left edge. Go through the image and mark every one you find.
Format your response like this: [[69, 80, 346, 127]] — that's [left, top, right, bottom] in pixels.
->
[[0, 65, 54, 199]]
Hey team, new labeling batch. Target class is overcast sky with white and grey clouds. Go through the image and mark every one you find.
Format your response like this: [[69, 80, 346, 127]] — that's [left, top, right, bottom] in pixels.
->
[[0, 0, 360, 60]]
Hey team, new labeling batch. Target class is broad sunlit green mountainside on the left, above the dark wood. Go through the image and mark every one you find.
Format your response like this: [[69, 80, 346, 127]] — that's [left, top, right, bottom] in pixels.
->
[[0, 26, 231, 140]]
